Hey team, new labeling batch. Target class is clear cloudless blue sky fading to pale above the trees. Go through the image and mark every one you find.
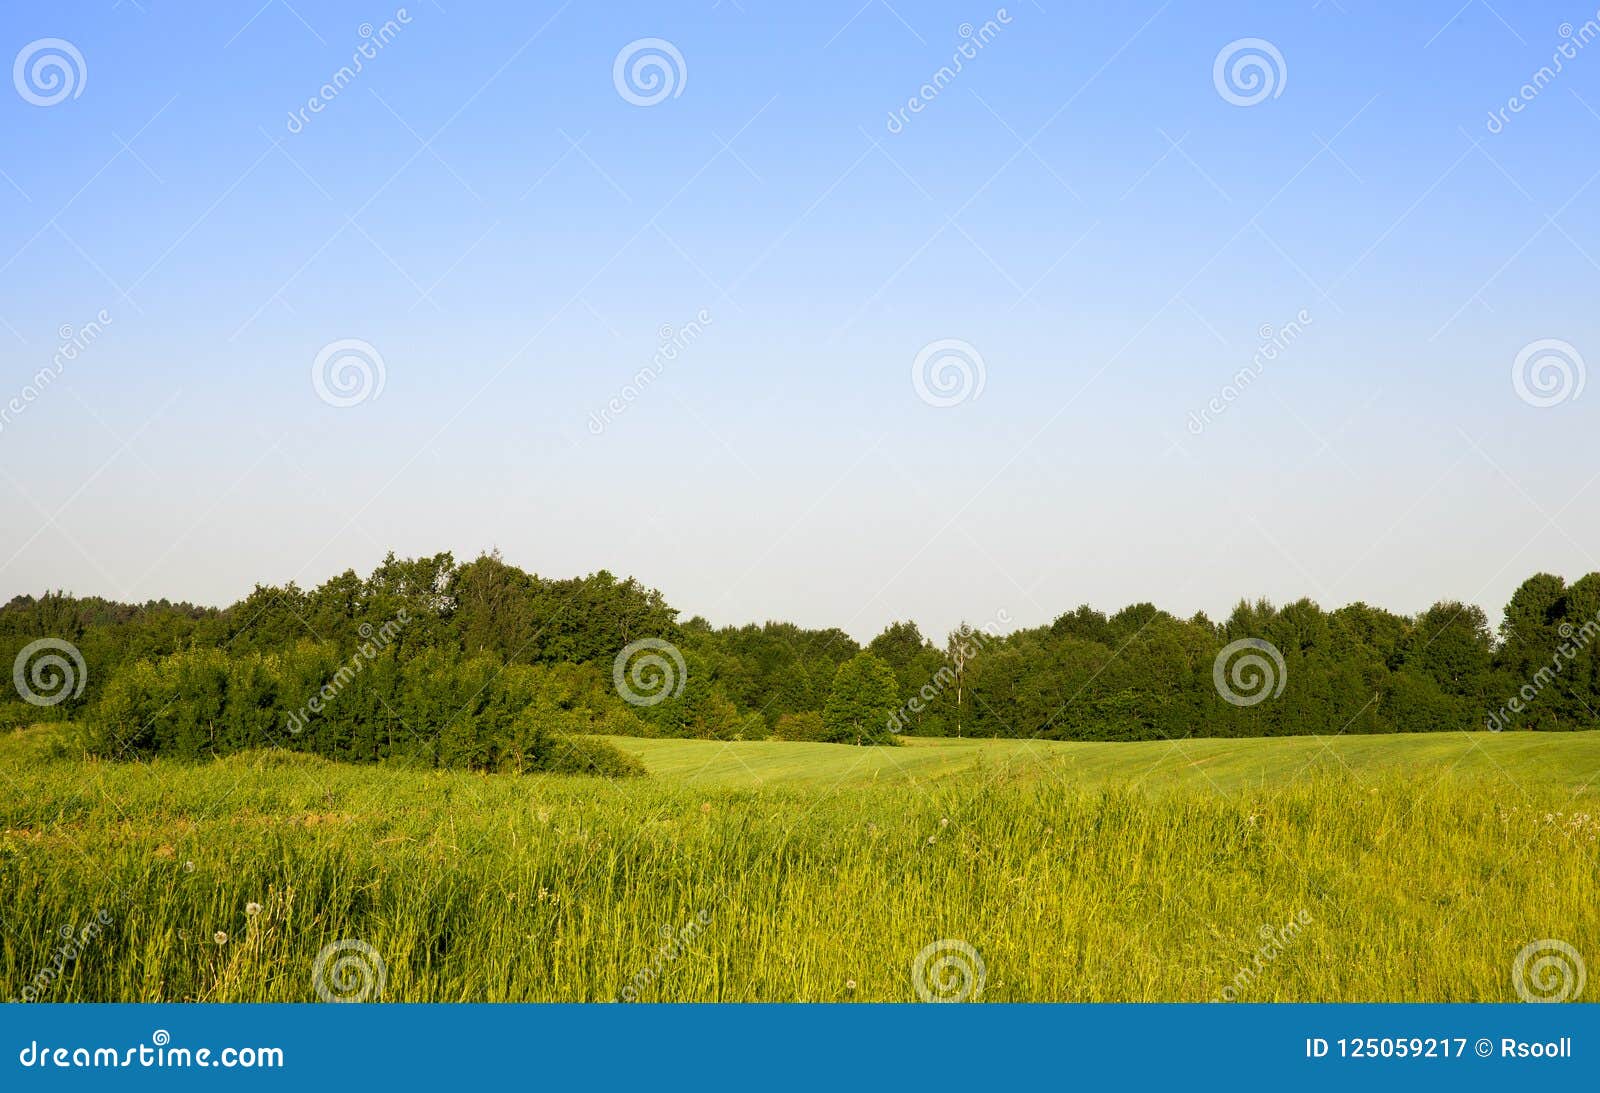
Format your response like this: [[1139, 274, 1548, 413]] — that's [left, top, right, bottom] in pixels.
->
[[0, 0, 1600, 637]]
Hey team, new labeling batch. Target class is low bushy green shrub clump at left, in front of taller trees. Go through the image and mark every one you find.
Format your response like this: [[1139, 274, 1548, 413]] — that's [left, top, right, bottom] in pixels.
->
[[85, 642, 637, 773]]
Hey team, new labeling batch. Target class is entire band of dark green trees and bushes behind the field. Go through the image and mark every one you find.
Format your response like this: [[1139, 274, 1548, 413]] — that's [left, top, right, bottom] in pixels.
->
[[0, 552, 1600, 775]]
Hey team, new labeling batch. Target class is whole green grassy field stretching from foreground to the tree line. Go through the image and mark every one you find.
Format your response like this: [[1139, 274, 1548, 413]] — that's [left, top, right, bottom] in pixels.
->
[[0, 728, 1600, 1002]]
